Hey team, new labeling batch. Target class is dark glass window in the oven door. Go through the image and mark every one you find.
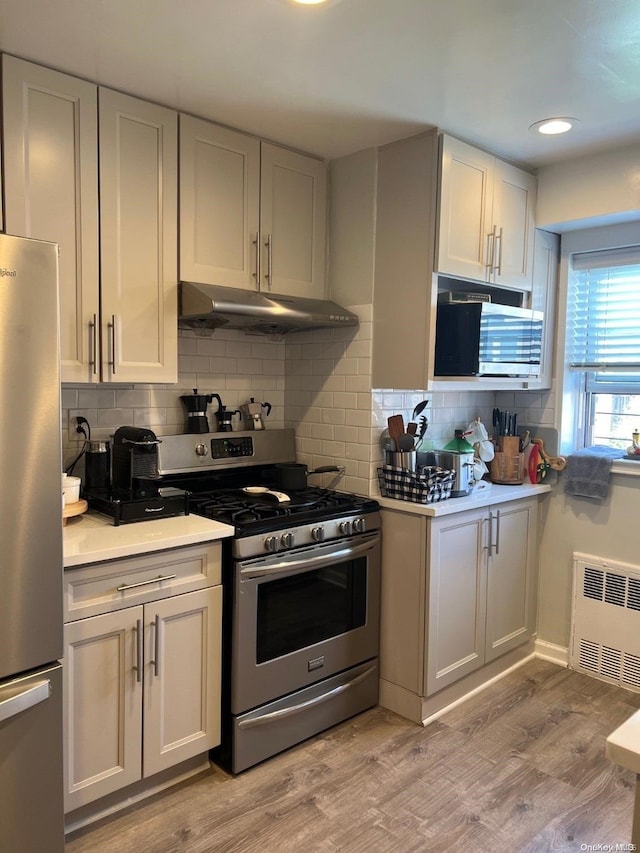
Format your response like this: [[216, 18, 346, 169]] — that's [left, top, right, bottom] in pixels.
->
[[256, 557, 367, 663]]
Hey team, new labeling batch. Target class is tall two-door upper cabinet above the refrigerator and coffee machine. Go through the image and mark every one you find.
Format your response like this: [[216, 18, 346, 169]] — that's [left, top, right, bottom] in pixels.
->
[[2, 56, 178, 382]]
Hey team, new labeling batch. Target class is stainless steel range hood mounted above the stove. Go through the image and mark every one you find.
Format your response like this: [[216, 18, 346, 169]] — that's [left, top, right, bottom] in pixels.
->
[[178, 281, 358, 335]]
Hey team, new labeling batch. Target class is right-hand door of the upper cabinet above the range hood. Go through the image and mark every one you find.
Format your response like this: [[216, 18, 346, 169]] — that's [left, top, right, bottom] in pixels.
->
[[260, 142, 327, 299]]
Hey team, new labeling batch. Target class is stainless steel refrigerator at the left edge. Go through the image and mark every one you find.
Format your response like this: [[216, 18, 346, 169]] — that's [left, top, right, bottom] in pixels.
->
[[0, 234, 64, 853]]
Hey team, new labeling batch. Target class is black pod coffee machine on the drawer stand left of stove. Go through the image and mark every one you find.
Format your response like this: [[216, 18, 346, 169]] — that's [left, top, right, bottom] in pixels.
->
[[111, 427, 160, 498]]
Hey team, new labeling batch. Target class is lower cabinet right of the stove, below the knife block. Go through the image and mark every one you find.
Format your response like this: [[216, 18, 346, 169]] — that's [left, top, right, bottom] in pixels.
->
[[380, 498, 538, 721]]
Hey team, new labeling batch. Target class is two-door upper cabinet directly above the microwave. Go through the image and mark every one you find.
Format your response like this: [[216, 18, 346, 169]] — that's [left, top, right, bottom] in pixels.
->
[[436, 135, 537, 290]]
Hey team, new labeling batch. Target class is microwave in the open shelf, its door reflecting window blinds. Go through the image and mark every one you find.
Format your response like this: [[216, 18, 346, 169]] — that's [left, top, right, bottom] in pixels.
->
[[435, 302, 544, 376]]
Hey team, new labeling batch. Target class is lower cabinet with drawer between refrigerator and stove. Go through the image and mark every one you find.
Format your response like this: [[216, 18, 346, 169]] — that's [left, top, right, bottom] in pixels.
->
[[64, 545, 222, 813]]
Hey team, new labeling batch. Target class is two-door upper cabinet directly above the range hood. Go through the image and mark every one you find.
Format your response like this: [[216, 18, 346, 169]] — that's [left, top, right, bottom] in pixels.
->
[[180, 116, 326, 298]]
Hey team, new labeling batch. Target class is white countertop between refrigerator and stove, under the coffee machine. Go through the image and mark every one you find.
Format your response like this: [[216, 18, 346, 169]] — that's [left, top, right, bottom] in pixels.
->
[[62, 512, 234, 569]]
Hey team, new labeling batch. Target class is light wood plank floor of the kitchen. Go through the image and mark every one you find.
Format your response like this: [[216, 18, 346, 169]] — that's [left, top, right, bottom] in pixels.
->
[[67, 660, 640, 853]]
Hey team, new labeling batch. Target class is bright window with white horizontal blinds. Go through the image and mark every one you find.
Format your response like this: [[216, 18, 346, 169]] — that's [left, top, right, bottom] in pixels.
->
[[567, 246, 640, 449]]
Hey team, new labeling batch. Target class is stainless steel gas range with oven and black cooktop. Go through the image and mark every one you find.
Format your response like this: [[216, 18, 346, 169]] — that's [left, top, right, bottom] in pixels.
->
[[158, 430, 380, 773]]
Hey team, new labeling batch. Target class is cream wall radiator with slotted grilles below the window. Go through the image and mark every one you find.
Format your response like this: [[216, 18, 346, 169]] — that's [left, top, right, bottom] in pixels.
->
[[569, 554, 640, 692]]
